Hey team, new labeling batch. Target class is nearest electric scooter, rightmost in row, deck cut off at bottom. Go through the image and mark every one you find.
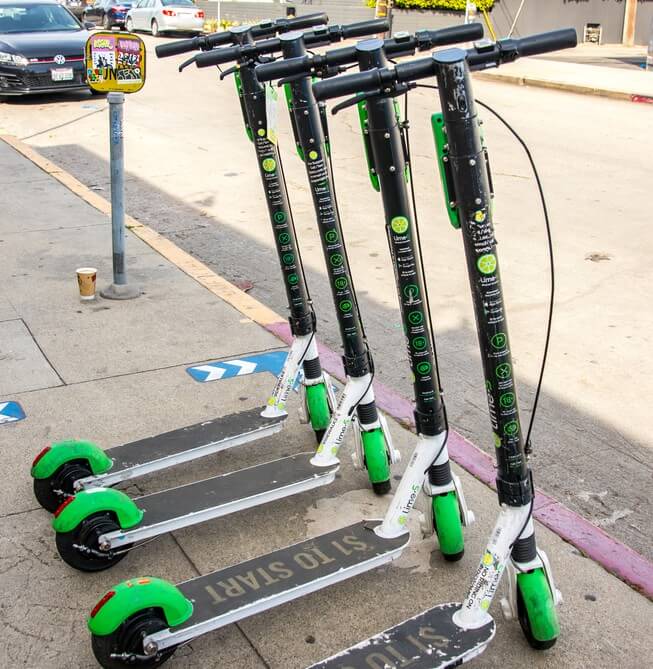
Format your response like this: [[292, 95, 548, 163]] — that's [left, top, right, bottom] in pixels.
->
[[312, 29, 577, 669]]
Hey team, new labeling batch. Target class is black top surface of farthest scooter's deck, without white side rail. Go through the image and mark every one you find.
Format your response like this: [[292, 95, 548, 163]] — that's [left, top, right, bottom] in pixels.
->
[[105, 407, 286, 474]]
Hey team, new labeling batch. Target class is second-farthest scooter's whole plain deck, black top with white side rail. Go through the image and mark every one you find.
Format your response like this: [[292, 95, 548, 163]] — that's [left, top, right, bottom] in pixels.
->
[[106, 452, 339, 547]]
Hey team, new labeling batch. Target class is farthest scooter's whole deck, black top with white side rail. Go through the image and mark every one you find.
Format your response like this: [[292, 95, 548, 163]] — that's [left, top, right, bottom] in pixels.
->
[[82, 407, 287, 485]]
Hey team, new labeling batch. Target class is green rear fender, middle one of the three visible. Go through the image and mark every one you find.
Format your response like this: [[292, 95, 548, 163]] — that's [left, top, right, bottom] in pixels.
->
[[52, 488, 143, 532]]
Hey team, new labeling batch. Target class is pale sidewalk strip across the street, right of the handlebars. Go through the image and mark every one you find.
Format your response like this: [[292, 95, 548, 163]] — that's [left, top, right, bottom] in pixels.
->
[[474, 44, 653, 102]]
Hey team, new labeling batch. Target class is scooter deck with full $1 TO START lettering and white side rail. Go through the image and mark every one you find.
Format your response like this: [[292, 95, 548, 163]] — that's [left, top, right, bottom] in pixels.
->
[[147, 521, 410, 648]]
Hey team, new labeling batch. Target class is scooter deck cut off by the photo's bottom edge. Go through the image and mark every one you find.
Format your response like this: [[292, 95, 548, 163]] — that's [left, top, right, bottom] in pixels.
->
[[308, 604, 496, 669]]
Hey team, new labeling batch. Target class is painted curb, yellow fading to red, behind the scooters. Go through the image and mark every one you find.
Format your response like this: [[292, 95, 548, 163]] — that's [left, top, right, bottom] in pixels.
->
[[5, 135, 653, 600]]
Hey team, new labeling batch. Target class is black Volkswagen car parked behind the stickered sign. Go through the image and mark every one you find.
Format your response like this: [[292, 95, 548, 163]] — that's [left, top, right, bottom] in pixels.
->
[[0, 0, 90, 98]]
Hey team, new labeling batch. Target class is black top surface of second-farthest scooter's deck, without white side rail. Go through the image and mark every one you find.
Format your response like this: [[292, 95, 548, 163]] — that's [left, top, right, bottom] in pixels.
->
[[130, 453, 339, 529]]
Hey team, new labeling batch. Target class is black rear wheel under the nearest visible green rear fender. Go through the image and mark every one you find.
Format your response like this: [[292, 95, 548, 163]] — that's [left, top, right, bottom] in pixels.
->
[[91, 608, 177, 669]]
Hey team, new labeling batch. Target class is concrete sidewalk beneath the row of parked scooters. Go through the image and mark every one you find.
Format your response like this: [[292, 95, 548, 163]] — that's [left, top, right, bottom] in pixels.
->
[[0, 137, 653, 669]]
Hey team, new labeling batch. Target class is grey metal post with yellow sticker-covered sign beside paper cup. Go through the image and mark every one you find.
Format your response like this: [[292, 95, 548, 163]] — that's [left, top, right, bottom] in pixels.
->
[[86, 32, 145, 300]]
